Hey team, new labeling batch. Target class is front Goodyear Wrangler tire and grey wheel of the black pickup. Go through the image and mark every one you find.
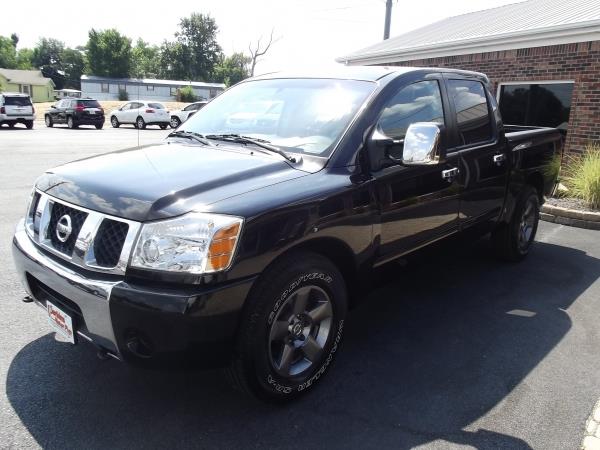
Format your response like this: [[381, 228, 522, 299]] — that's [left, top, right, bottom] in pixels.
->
[[229, 252, 347, 403]]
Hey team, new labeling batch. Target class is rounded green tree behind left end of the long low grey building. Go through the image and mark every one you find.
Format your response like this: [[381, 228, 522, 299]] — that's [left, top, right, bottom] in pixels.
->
[[86, 28, 131, 77]]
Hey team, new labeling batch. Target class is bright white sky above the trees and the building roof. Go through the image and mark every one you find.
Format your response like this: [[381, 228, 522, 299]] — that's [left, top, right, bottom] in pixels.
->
[[0, 0, 517, 74]]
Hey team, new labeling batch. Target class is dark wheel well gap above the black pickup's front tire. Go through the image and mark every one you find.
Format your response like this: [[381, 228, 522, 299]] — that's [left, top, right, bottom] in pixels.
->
[[278, 238, 360, 307]]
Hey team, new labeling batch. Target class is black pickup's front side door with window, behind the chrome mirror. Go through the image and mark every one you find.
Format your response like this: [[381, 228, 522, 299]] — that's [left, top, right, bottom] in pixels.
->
[[373, 75, 460, 263]]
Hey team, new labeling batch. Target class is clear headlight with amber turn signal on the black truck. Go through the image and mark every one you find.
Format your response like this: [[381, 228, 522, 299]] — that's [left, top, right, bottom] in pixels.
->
[[131, 213, 243, 273]]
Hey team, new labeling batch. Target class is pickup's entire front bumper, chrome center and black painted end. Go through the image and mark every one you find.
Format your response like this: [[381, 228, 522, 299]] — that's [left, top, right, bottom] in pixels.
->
[[13, 221, 254, 365]]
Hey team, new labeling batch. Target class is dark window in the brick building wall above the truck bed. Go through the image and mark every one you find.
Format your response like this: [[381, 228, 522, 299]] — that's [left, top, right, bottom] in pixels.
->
[[498, 81, 573, 134]]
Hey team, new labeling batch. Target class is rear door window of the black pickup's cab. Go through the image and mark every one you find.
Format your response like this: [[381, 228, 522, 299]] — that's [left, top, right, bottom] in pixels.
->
[[448, 80, 492, 145]]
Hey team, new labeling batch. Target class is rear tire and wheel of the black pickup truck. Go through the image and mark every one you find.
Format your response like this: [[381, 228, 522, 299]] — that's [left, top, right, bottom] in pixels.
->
[[492, 186, 540, 262]]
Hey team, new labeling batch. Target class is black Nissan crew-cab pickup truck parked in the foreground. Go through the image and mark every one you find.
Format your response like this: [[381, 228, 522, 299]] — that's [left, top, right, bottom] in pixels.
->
[[13, 67, 561, 401]]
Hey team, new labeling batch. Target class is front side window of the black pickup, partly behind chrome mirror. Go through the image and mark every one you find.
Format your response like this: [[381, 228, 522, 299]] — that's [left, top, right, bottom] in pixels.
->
[[378, 80, 444, 139]]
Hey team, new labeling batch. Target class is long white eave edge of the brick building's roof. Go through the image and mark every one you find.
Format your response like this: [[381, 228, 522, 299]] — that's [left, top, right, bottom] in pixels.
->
[[336, 20, 600, 65]]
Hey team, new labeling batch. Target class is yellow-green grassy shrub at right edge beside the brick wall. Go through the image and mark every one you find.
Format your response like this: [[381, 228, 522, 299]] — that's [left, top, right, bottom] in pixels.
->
[[563, 143, 600, 209]]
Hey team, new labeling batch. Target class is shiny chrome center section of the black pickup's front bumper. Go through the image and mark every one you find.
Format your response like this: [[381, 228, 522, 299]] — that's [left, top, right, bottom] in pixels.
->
[[12, 220, 120, 356]]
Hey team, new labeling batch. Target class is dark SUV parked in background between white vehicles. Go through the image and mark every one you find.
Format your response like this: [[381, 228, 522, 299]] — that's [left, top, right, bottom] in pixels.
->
[[44, 98, 104, 130]]
